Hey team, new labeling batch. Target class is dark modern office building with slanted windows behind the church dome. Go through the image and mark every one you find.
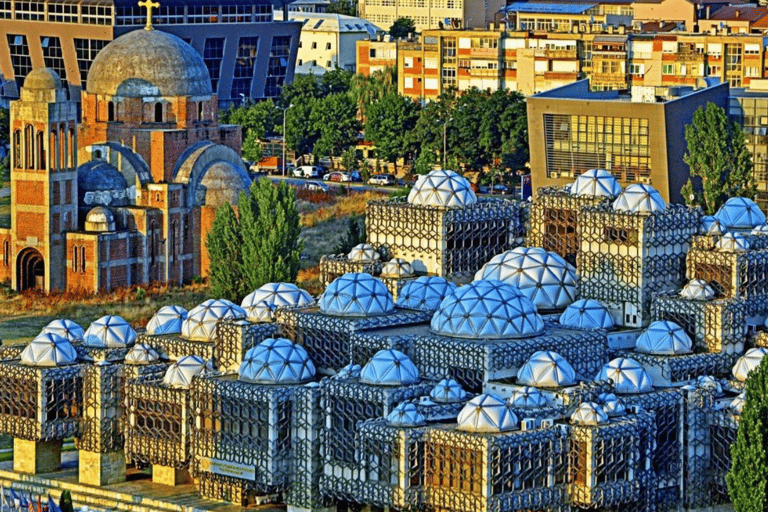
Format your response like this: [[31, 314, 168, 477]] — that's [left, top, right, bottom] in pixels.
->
[[0, 0, 301, 105]]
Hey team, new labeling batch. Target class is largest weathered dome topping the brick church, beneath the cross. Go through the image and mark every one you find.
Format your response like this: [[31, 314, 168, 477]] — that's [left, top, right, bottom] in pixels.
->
[[86, 30, 212, 97]]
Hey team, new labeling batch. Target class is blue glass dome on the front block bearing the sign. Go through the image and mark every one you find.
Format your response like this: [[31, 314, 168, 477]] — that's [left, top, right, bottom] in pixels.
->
[[238, 338, 315, 384]]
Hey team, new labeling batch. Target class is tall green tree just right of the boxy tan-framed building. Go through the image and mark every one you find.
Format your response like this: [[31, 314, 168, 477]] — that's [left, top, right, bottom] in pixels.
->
[[681, 103, 757, 215]]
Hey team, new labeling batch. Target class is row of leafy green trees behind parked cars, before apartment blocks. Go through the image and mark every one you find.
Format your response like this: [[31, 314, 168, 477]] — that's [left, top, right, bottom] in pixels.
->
[[216, 69, 528, 180]]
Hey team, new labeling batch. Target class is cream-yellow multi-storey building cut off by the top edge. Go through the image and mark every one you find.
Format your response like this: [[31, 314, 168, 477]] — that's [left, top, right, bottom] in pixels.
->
[[358, 0, 505, 32]]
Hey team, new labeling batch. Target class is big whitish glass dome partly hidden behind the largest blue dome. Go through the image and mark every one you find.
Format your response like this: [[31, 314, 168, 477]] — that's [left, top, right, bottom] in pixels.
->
[[475, 247, 578, 309]]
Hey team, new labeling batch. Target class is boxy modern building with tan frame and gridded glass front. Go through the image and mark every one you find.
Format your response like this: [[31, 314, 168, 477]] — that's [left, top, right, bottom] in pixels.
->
[[527, 80, 728, 203]]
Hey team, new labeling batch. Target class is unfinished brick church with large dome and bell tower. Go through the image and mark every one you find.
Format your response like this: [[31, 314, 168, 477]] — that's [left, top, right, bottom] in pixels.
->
[[0, 20, 250, 292]]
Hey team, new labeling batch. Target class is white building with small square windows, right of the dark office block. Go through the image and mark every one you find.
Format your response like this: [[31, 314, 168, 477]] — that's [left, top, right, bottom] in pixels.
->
[[276, 11, 384, 75]]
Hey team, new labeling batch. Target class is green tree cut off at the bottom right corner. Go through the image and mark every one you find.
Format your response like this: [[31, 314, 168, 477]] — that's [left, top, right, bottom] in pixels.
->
[[726, 358, 768, 512]]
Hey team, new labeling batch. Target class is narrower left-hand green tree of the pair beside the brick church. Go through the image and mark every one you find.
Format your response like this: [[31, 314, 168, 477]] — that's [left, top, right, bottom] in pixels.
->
[[206, 203, 245, 304]]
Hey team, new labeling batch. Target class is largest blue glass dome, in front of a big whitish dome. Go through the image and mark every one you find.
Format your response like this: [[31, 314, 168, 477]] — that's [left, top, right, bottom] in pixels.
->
[[431, 281, 544, 339]]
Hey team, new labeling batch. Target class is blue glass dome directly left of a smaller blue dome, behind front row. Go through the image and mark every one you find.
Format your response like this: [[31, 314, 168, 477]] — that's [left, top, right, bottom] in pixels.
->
[[320, 273, 395, 316]]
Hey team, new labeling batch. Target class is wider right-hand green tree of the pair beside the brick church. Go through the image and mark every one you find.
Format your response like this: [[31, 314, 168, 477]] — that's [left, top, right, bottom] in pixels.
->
[[238, 178, 303, 292]]
